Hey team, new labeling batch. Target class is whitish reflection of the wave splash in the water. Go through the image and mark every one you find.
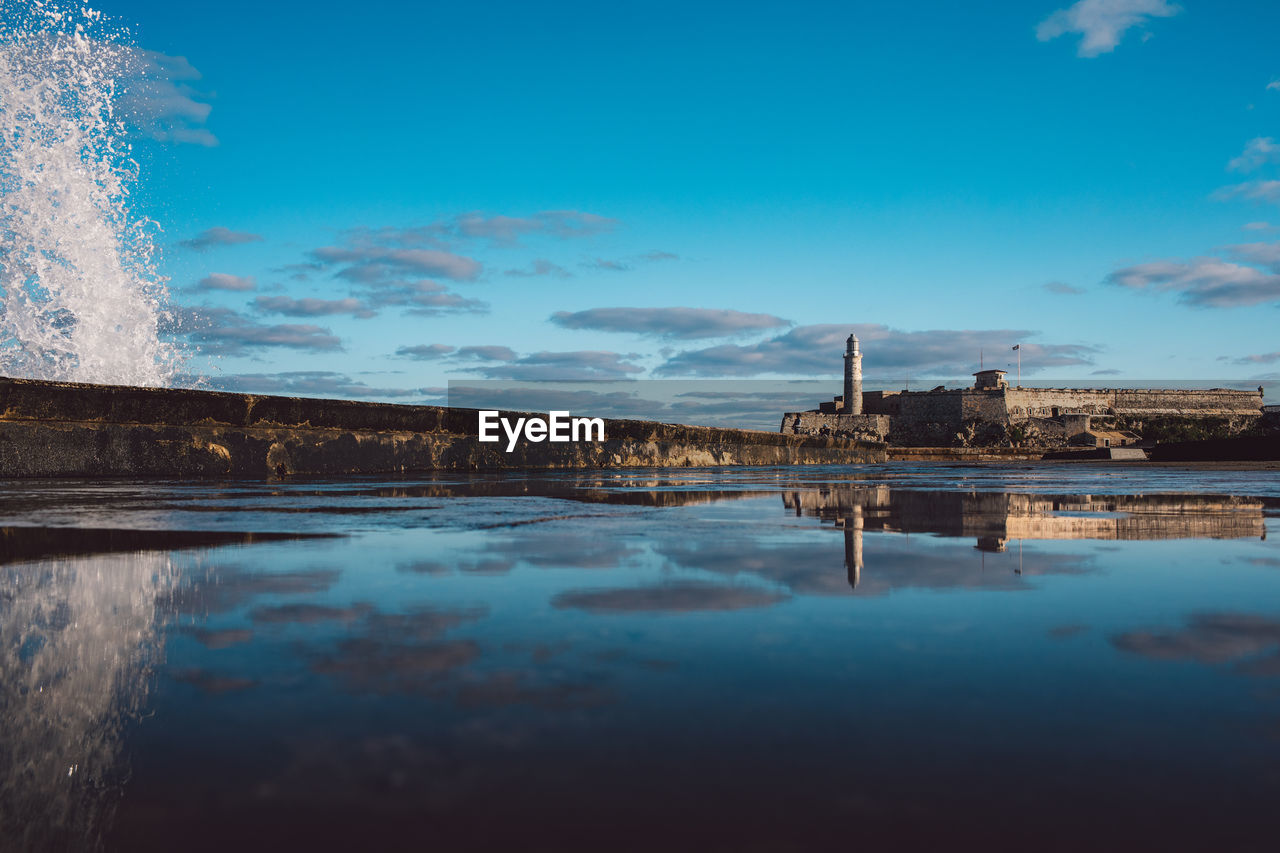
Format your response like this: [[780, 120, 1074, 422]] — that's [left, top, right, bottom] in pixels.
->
[[0, 552, 175, 850]]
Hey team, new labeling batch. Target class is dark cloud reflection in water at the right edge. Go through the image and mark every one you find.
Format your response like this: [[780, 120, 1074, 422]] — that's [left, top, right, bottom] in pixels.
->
[[1111, 612, 1280, 675]]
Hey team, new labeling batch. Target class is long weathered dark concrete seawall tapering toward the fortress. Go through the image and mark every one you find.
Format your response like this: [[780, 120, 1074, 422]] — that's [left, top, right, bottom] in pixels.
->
[[0, 378, 884, 478]]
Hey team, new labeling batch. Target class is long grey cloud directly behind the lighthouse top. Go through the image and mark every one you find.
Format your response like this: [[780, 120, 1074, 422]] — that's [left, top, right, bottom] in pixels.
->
[[655, 323, 1098, 377]]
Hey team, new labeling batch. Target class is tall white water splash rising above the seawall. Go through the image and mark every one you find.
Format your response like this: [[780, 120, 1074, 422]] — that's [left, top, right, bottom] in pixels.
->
[[0, 0, 180, 386]]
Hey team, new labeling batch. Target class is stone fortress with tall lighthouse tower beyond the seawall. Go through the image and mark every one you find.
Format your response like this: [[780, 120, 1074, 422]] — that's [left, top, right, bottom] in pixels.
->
[[780, 334, 1263, 448]]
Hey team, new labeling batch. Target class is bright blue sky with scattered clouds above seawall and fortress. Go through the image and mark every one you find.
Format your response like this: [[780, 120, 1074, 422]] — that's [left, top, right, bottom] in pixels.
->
[[101, 0, 1280, 400]]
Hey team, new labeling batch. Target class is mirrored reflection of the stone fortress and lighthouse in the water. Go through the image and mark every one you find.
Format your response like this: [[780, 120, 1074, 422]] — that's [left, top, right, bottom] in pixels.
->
[[782, 485, 1266, 587]]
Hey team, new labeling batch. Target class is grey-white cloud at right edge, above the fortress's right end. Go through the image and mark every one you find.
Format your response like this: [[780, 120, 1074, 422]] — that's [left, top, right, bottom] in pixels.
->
[[1106, 243, 1280, 307]]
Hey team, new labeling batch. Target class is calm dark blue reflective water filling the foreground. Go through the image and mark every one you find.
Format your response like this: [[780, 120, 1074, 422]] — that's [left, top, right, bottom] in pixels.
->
[[0, 465, 1280, 850]]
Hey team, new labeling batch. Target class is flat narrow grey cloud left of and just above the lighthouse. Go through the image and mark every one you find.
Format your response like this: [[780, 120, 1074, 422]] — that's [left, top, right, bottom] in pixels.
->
[[550, 307, 791, 341]]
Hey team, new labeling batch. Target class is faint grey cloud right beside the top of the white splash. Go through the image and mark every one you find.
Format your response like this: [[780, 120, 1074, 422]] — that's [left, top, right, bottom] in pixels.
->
[[120, 49, 218, 147]]
